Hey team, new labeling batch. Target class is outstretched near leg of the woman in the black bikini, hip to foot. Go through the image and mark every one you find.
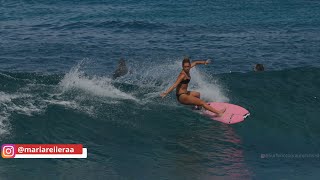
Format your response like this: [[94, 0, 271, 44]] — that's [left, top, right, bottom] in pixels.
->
[[179, 94, 226, 116]]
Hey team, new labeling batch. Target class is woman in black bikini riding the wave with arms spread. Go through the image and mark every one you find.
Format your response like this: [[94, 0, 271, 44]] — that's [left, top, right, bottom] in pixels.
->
[[160, 58, 226, 117]]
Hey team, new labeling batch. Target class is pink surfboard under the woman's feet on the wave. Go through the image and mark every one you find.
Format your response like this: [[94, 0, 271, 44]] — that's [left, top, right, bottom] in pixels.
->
[[202, 102, 250, 124]]
